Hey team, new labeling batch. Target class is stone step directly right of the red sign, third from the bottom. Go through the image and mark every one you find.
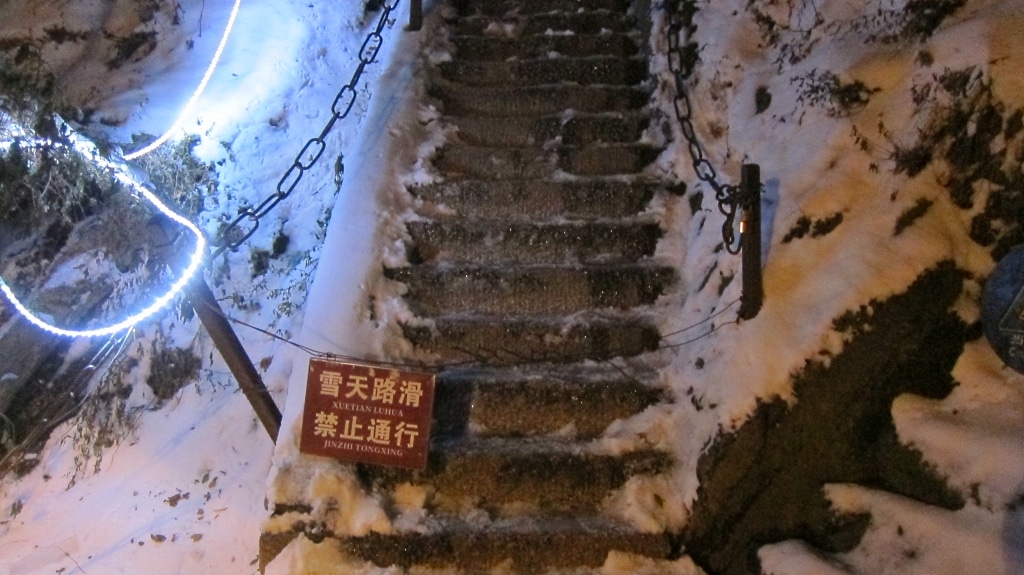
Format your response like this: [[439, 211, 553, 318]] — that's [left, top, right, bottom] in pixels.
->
[[433, 364, 663, 439]]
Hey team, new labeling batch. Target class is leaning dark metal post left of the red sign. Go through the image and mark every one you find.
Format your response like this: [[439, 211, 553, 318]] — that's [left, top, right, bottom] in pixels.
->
[[188, 274, 281, 443]]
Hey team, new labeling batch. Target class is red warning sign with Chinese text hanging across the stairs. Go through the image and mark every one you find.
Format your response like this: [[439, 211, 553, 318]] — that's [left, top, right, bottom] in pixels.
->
[[299, 358, 434, 470]]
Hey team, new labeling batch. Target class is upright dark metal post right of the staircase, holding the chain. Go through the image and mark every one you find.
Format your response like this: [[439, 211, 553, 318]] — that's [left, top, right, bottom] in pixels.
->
[[739, 164, 765, 319]]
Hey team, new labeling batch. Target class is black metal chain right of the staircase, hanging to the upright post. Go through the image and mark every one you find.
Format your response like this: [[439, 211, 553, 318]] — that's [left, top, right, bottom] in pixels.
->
[[665, 0, 741, 255]]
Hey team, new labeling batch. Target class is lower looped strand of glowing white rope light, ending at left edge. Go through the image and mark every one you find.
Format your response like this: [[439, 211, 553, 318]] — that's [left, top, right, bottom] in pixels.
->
[[0, 132, 206, 338]]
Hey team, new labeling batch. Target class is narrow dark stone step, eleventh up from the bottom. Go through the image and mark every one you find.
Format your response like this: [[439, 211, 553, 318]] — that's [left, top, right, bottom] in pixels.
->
[[437, 56, 647, 87]]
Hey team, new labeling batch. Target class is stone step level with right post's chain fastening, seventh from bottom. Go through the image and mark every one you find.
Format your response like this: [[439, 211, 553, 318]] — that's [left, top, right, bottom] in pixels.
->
[[410, 178, 656, 223]]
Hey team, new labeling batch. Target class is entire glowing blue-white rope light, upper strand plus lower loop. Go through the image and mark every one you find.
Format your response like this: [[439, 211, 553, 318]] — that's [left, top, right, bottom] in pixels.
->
[[0, 0, 242, 338]]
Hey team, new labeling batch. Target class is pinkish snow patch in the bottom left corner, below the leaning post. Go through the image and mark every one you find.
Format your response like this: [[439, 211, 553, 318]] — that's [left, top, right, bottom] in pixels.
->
[[0, 390, 269, 575]]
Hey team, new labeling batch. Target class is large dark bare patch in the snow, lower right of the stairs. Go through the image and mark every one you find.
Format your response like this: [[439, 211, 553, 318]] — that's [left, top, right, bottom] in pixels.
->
[[683, 263, 978, 575]]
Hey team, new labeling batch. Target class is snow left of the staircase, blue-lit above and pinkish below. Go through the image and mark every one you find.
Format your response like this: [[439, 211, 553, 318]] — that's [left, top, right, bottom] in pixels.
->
[[0, 0, 407, 575]]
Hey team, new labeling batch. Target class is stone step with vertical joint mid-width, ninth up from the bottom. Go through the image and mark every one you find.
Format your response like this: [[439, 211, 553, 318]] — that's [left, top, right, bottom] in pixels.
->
[[446, 112, 650, 147]]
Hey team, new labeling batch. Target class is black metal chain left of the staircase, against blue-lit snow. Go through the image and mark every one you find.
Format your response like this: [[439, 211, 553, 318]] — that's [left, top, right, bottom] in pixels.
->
[[210, 0, 398, 258]]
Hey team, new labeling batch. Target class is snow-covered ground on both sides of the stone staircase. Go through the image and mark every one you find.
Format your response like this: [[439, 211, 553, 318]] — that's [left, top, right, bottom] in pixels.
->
[[0, 0, 1024, 575]]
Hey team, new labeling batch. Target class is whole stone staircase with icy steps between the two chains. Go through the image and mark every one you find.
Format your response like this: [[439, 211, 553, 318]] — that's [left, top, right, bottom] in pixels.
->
[[341, 0, 676, 573]]
